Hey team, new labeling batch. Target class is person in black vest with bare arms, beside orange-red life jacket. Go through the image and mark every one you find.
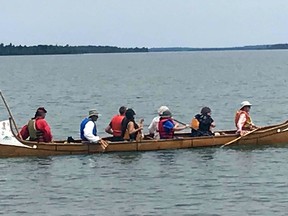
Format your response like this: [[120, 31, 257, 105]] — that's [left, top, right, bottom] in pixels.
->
[[121, 108, 144, 140]]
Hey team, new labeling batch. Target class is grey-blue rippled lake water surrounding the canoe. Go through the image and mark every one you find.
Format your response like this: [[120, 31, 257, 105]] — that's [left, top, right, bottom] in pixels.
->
[[0, 50, 288, 216]]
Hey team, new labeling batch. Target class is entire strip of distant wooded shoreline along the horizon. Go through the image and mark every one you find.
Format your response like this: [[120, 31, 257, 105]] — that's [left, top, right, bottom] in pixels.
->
[[0, 43, 288, 56]]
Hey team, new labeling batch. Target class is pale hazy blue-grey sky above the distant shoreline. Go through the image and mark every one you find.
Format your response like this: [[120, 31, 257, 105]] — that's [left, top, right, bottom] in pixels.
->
[[0, 0, 288, 48]]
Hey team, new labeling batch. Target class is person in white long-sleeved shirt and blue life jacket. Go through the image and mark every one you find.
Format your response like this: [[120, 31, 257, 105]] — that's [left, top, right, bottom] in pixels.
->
[[80, 109, 100, 143]]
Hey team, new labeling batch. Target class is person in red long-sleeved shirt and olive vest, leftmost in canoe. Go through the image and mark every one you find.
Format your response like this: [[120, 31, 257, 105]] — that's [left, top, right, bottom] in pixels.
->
[[20, 107, 53, 142]]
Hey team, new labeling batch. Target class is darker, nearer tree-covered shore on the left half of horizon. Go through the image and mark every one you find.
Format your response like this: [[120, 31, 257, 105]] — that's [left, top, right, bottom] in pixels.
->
[[0, 43, 148, 55]]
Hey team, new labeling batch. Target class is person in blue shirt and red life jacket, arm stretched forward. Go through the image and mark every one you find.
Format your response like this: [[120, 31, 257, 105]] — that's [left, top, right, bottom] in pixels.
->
[[158, 110, 187, 139]]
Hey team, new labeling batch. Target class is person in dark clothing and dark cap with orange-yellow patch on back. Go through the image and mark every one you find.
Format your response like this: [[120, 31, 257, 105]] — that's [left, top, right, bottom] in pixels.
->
[[191, 107, 216, 137]]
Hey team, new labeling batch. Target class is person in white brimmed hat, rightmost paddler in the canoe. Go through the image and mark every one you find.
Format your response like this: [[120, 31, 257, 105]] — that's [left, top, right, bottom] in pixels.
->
[[235, 101, 257, 136]]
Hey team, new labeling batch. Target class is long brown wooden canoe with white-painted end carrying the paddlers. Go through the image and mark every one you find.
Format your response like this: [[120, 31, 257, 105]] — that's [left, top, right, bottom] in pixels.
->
[[0, 121, 288, 157]]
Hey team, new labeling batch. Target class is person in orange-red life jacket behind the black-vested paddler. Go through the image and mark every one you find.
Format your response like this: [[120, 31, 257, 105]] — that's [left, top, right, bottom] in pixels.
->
[[105, 106, 127, 141]]
